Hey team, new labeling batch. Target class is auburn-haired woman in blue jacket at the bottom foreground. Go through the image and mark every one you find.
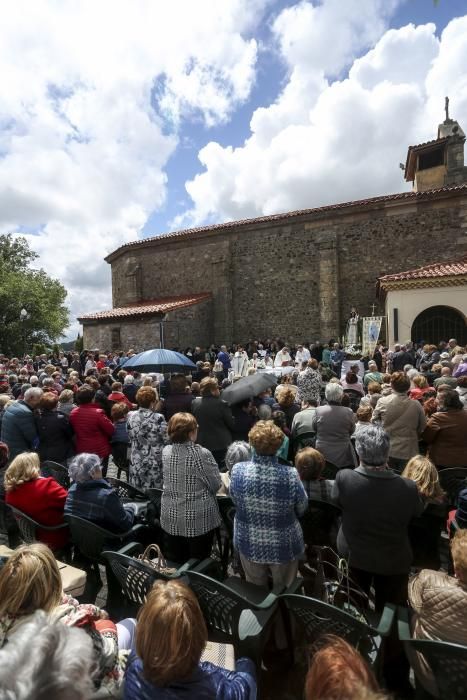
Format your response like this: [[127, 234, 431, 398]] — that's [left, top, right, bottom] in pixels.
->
[[124, 580, 256, 700]]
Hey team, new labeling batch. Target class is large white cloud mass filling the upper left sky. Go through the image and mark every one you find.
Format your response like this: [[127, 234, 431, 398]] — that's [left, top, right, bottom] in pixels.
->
[[0, 0, 269, 336]]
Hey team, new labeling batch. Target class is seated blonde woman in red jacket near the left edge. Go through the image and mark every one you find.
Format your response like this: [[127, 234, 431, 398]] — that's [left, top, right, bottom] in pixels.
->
[[5, 452, 69, 550]]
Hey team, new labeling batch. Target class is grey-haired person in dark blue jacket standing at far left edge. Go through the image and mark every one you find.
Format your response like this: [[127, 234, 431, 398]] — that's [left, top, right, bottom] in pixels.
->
[[1, 387, 43, 461]]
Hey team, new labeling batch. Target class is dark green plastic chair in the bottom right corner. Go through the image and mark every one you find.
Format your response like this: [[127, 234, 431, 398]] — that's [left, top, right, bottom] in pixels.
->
[[397, 608, 467, 700]]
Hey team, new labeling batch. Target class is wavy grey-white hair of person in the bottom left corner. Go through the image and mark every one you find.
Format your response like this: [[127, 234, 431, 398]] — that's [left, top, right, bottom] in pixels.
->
[[0, 611, 97, 700]]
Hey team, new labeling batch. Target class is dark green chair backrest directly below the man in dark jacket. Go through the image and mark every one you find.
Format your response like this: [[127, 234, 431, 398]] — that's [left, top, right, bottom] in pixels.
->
[[279, 593, 379, 663]]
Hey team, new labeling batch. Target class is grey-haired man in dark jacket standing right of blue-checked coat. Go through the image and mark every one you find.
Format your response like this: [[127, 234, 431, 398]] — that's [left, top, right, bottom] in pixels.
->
[[332, 424, 424, 610]]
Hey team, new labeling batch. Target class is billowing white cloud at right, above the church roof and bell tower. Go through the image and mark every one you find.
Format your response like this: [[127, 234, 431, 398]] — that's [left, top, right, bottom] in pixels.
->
[[178, 8, 467, 225]]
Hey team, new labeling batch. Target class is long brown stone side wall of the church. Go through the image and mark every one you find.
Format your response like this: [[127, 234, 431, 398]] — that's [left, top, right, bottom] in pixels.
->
[[105, 193, 467, 346]]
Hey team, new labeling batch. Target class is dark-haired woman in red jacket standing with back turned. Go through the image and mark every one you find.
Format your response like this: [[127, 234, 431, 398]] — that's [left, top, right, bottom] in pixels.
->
[[70, 384, 114, 476]]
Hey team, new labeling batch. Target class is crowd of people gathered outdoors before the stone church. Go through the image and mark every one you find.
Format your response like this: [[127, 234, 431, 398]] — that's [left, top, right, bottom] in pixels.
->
[[0, 339, 467, 700]]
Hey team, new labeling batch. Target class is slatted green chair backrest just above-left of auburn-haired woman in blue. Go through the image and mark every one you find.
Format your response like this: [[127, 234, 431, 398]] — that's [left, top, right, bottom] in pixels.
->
[[102, 552, 166, 605]]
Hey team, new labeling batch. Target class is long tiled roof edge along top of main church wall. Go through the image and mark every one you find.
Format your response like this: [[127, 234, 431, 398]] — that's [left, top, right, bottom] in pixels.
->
[[106, 184, 467, 262]]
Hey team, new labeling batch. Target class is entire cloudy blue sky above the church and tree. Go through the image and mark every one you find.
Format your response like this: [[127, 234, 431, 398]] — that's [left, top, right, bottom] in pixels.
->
[[0, 0, 467, 336]]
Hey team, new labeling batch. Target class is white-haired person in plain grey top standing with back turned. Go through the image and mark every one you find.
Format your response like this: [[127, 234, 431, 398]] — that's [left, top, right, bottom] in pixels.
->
[[313, 382, 356, 469]]
